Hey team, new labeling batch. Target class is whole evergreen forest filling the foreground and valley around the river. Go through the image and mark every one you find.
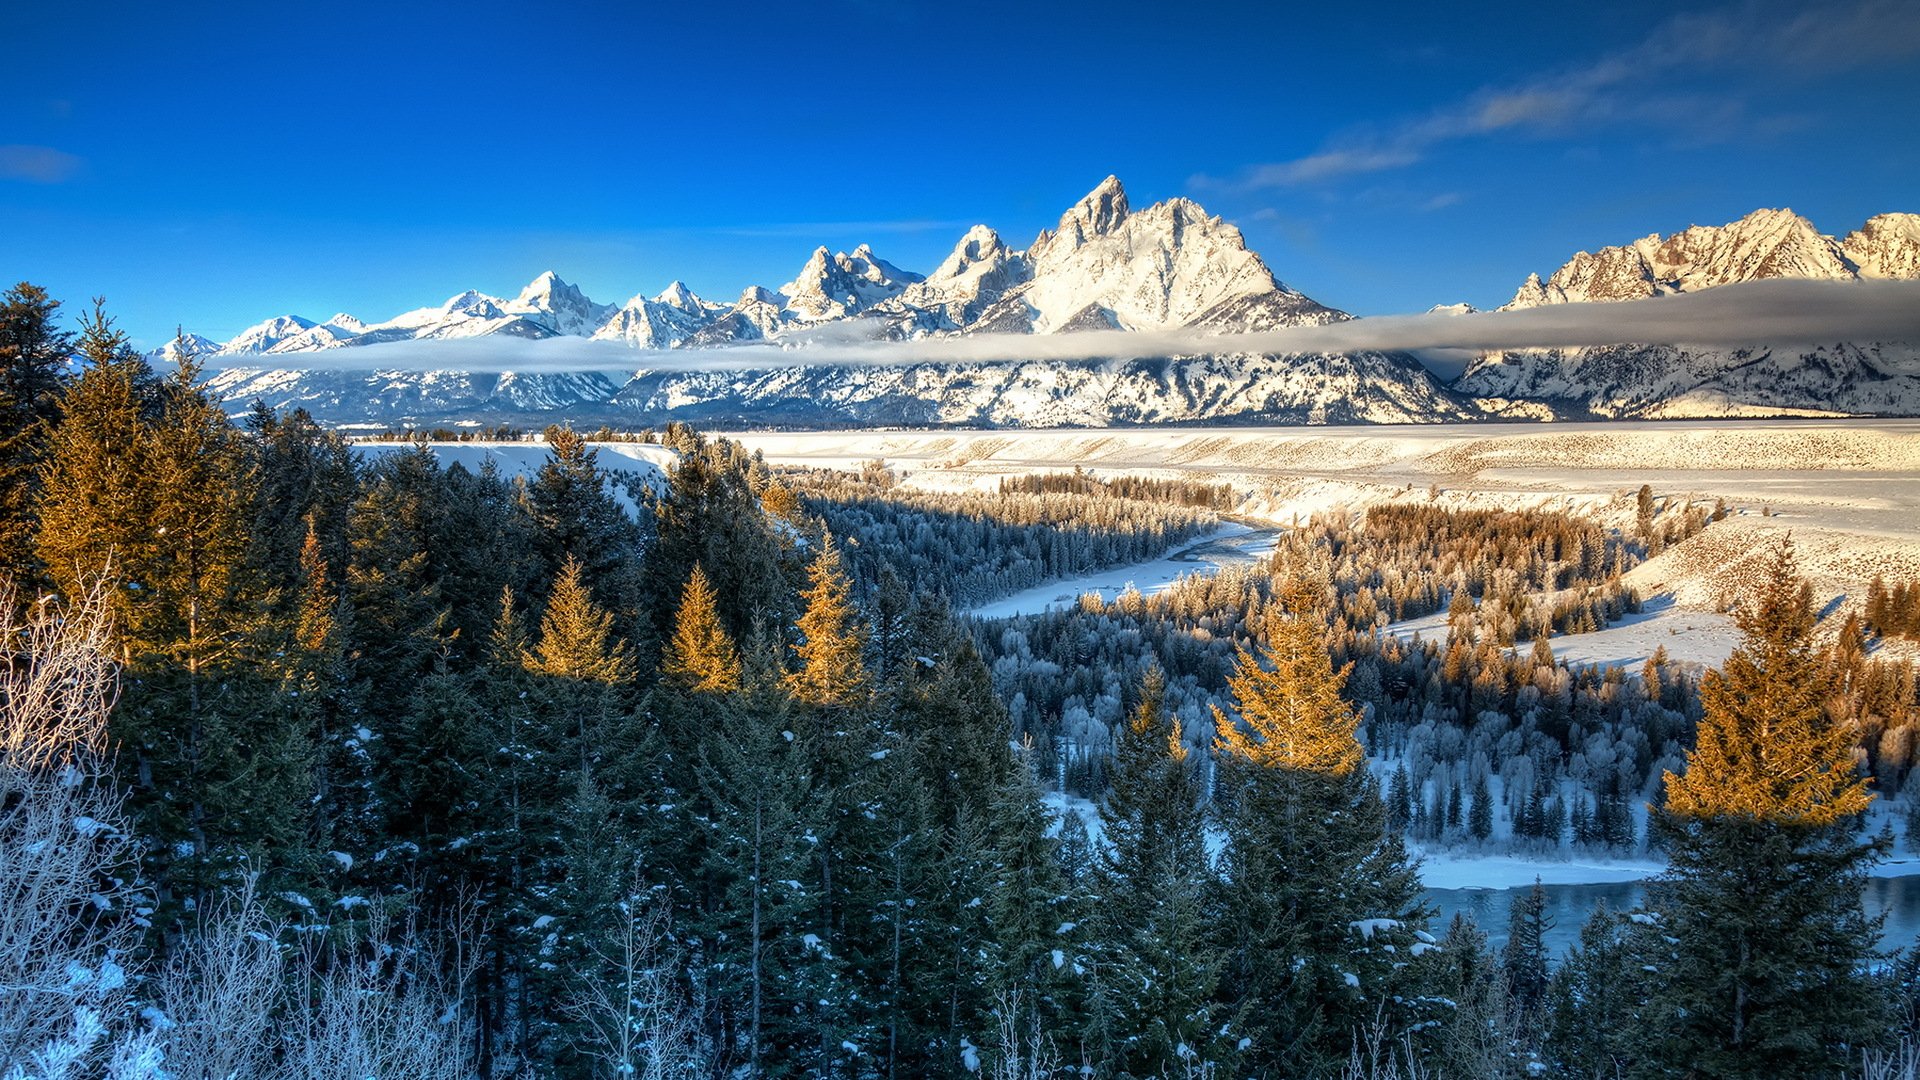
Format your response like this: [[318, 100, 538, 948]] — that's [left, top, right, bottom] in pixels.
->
[[0, 284, 1920, 1080]]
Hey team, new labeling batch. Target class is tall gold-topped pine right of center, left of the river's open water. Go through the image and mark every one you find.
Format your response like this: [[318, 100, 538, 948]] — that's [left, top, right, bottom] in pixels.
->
[[1215, 578, 1427, 1076]]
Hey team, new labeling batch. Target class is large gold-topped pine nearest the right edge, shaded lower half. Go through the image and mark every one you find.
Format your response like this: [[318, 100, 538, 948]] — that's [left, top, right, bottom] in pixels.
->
[[1649, 540, 1884, 1078]]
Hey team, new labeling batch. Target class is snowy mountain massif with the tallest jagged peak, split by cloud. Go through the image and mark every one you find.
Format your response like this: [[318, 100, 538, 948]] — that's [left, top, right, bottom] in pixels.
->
[[198, 177, 1484, 427]]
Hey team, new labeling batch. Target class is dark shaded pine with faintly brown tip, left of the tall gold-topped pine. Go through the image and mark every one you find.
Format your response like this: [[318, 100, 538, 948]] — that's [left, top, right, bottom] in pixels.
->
[[1096, 667, 1219, 1076]]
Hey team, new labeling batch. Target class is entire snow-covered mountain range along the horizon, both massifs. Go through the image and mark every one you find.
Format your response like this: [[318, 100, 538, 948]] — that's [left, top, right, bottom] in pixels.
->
[[188, 177, 1920, 427]]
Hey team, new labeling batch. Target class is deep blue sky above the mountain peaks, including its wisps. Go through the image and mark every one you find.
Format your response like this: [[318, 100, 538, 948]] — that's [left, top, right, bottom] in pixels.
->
[[0, 0, 1920, 344]]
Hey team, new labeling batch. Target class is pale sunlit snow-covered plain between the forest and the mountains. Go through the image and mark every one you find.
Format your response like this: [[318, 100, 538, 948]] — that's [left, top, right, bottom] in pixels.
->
[[732, 419, 1920, 663]]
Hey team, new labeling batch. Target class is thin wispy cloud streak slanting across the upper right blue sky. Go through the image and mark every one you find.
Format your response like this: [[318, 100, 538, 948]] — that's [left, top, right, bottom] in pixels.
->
[[1192, 0, 1920, 190]]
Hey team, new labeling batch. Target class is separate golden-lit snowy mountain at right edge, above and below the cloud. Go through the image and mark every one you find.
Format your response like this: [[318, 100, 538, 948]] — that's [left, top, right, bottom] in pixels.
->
[[1453, 209, 1920, 417]]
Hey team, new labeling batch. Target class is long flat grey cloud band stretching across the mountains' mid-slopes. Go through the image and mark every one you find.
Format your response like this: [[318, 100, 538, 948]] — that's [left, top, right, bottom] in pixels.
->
[[213, 281, 1920, 373]]
